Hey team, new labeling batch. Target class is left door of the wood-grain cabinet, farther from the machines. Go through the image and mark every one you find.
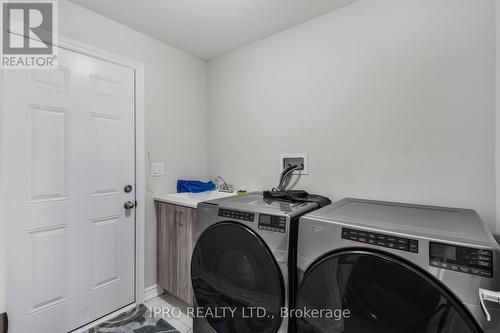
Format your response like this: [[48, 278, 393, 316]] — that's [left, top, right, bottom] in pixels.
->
[[157, 203, 179, 296]]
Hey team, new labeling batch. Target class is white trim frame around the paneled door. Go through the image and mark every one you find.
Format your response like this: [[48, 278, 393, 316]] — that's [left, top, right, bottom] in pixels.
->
[[0, 37, 146, 316]]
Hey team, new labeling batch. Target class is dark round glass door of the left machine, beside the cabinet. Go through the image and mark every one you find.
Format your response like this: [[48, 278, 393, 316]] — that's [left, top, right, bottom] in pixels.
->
[[191, 222, 285, 333]]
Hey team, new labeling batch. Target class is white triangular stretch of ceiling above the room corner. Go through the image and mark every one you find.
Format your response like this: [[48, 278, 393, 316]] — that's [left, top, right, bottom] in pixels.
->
[[71, 0, 357, 60]]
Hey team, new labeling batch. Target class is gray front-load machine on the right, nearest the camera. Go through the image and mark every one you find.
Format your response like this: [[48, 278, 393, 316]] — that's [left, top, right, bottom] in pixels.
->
[[296, 199, 500, 333]]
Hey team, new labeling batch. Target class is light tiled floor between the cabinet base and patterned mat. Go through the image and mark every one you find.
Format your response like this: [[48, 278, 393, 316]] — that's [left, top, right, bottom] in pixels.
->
[[144, 294, 193, 333]]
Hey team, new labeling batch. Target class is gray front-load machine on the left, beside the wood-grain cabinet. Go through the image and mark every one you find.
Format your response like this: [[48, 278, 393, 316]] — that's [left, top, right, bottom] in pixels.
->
[[191, 192, 324, 333]]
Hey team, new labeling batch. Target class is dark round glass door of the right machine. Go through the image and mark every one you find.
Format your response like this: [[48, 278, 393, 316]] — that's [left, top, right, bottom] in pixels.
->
[[296, 251, 480, 333]]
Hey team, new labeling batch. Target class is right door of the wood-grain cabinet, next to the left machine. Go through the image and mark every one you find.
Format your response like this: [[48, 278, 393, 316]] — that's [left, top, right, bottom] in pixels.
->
[[177, 207, 196, 304]]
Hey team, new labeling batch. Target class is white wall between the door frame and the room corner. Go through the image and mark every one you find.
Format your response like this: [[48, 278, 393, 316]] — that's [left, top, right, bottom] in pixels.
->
[[59, 0, 207, 287]]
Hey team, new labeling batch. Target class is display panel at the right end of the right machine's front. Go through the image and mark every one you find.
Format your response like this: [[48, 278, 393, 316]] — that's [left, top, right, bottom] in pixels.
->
[[429, 242, 493, 278]]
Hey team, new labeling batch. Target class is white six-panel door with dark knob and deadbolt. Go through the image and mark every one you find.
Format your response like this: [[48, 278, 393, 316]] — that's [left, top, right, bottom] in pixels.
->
[[4, 45, 135, 333]]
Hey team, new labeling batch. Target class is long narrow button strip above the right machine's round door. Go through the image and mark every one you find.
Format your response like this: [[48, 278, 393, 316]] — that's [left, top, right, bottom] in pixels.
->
[[342, 228, 418, 253]]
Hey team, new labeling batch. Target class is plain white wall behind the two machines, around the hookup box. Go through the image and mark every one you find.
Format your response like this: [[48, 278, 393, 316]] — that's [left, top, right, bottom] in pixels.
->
[[208, 0, 495, 228]]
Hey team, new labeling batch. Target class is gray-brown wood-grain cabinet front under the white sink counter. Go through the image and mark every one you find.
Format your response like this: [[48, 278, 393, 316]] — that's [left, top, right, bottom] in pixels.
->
[[156, 201, 196, 304]]
